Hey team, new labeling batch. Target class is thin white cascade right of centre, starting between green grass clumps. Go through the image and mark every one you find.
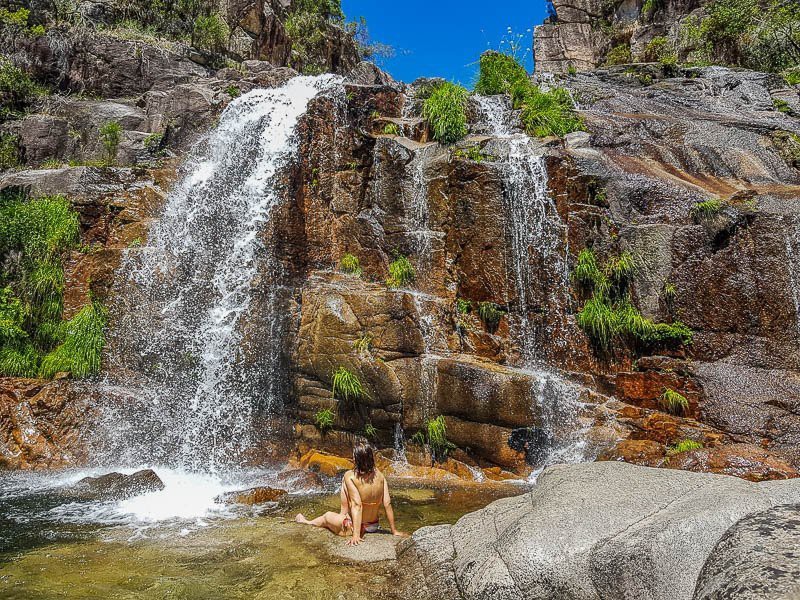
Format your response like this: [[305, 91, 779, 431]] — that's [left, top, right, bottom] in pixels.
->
[[477, 96, 585, 472]]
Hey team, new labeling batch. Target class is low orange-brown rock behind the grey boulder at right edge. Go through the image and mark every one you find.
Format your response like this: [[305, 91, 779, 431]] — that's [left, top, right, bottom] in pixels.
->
[[665, 444, 800, 481]]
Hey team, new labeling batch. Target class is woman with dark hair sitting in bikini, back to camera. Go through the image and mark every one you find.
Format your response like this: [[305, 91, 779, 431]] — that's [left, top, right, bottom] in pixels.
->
[[295, 442, 406, 546]]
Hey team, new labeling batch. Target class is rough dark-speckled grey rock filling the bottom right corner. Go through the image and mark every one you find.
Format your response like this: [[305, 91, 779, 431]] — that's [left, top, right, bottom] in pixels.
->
[[694, 504, 800, 600]]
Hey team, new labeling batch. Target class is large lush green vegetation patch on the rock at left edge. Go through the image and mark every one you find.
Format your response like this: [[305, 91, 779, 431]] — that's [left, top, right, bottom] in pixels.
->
[[0, 193, 105, 377]]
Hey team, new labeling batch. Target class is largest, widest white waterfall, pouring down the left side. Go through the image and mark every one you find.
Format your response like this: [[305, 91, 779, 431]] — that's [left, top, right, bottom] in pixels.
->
[[101, 75, 338, 472]]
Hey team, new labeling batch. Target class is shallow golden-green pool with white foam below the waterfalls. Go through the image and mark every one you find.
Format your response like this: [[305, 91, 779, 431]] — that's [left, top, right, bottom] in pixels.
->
[[0, 470, 522, 600]]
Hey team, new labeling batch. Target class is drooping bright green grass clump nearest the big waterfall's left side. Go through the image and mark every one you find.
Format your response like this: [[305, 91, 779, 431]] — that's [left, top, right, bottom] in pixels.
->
[[39, 302, 106, 379]]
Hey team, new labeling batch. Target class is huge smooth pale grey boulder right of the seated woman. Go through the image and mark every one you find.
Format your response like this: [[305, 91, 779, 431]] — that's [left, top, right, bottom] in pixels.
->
[[398, 463, 800, 600]]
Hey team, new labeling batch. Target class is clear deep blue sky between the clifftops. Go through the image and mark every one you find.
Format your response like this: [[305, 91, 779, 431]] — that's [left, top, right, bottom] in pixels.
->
[[342, 0, 545, 87]]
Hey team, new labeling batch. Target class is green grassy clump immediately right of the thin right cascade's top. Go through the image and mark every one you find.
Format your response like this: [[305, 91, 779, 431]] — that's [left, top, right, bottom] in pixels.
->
[[512, 81, 583, 137]]
